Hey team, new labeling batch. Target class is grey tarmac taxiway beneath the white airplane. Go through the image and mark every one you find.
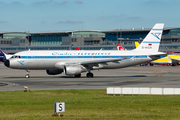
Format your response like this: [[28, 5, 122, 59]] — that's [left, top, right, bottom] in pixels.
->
[[0, 64, 180, 91]]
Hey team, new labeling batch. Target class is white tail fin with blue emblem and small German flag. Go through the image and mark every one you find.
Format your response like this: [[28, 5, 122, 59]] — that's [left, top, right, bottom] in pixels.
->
[[135, 23, 164, 52]]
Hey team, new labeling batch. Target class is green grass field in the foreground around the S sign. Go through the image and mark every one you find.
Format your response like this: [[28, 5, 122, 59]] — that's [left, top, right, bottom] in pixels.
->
[[0, 90, 180, 120]]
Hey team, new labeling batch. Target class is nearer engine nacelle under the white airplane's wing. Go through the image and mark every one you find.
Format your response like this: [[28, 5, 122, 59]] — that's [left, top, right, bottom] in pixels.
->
[[64, 65, 87, 75]]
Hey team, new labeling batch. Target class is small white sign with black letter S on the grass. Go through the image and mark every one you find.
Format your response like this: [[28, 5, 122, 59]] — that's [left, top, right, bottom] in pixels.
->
[[54, 102, 65, 113]]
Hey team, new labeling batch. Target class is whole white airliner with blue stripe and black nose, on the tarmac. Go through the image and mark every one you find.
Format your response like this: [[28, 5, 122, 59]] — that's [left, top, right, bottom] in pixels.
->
[[4, 23, 166, 78]]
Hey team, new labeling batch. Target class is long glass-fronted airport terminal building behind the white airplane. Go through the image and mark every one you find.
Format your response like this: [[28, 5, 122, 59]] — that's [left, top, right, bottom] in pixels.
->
[[0, 28, 180, 53]]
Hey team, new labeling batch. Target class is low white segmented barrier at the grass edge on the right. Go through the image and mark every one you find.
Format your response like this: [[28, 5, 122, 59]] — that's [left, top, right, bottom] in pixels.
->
[[106, 87, 180, 95]]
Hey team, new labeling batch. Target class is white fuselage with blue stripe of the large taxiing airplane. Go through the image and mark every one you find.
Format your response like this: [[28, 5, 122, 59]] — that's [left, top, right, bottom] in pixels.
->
[[10, 50, 162, 70]]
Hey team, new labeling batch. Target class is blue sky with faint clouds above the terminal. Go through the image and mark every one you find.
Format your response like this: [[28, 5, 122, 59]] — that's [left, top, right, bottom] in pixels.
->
[[0, 0, 180, 32]]
